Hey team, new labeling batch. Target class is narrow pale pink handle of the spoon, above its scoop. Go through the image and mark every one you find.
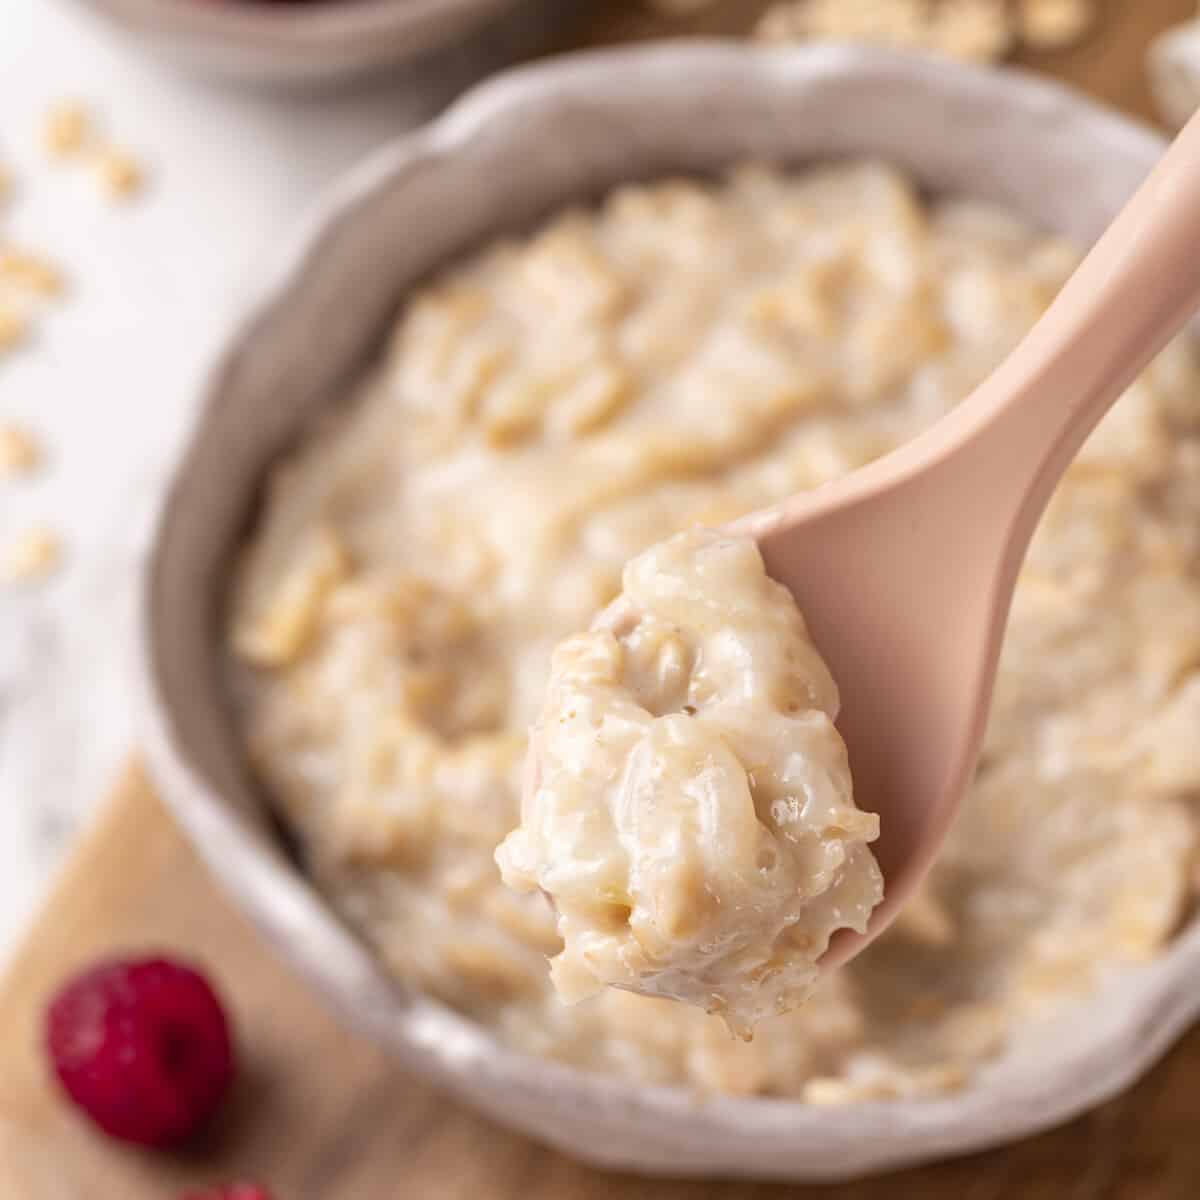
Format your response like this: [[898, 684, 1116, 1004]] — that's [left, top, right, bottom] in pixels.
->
[[936, 106, 1200, 530]]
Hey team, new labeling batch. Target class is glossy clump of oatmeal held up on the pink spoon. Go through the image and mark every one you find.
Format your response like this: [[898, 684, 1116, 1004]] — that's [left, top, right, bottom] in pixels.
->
[[497, 528, 883, 1036]]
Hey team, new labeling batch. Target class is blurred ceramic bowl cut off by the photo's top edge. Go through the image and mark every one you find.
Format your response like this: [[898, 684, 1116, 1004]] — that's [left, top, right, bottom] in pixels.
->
[[66, 0, 530, 85]]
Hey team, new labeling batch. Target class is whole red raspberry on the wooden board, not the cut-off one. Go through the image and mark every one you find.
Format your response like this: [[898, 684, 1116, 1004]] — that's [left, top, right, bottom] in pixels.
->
[[46, 959, 234, 1146]]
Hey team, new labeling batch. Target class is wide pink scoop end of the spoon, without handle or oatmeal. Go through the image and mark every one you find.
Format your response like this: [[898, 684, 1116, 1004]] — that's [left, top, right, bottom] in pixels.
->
[[734, 420, 1016, 968]]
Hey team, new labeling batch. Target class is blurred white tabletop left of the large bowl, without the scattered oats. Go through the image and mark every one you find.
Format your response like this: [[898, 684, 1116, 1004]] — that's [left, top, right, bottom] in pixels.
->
[[0, 0, 566, 964]]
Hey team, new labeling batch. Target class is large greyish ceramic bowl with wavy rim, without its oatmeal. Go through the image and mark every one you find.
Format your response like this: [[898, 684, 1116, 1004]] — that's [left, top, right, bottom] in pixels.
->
[[136, 44, 1200, 1181]]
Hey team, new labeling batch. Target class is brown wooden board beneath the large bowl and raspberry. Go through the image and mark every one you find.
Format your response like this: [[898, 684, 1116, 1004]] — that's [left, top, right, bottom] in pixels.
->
[[0, 0, 1200, 1200]]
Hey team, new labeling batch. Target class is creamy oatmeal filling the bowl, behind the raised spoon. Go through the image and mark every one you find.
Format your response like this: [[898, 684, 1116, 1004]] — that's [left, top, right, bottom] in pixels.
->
[[230, 164, 1200, 1103]]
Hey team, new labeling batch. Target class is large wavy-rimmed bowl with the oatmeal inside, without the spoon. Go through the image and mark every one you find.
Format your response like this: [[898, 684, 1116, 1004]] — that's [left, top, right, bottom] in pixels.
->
[[144, 44, 1200, 1181]]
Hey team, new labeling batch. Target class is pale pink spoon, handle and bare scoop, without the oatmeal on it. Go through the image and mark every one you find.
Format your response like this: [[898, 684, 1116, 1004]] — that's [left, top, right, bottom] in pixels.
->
[[734, 108, 1200, 966]]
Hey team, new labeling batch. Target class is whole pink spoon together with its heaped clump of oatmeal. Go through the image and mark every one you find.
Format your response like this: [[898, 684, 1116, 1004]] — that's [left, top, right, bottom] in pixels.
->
[[497, 108, 1200, 1036]]
